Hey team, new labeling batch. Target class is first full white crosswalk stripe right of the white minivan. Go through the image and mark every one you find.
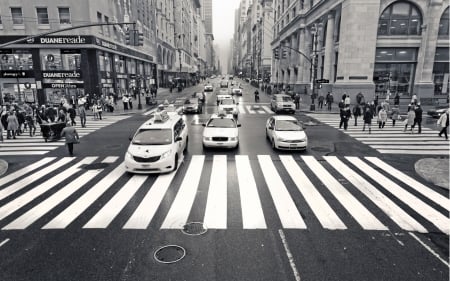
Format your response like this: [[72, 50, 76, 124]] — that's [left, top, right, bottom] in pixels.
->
[[161, 155, 205, 229]]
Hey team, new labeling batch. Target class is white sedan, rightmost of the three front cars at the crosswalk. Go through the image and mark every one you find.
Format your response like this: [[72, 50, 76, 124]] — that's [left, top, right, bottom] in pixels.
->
[[266, 115, 308, 150]]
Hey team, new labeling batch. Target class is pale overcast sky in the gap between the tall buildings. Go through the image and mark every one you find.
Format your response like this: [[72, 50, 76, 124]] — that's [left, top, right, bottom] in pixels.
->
[[213, 0, 240, 73]]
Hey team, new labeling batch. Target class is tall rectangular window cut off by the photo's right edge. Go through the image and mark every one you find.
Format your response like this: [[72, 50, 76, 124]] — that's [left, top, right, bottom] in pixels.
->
[[433, 47, 450, 95]]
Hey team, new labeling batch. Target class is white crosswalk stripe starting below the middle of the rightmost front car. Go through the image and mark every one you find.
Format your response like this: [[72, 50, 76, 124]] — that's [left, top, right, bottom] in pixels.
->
[[279, 155, 347, 229]]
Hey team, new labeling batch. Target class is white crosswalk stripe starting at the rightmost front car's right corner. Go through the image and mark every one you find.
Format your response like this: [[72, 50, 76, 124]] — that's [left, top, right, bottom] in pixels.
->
[[302, 156, 388, 230]]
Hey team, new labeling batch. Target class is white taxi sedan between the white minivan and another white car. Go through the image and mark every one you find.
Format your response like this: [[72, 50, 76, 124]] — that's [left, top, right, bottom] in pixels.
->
[[203, 112, 241, 148]]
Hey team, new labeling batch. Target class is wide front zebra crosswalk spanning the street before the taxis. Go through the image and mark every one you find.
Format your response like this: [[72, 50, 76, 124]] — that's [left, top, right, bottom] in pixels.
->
[[0, 155, 450, 235]]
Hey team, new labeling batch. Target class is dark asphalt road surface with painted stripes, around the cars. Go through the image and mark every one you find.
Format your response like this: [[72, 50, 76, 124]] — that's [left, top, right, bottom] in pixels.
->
[[0, 77, 449, 281]]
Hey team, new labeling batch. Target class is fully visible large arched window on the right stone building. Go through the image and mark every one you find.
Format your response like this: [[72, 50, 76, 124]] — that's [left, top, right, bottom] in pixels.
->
[[378, 1, 422, 35]]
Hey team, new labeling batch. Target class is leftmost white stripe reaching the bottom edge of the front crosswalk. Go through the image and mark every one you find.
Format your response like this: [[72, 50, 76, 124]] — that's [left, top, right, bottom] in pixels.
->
[[2, 169, 103, 230]]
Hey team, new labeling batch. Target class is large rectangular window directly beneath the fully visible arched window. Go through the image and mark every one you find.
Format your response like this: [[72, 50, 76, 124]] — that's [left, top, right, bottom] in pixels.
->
[[373, 48, 417, 96]]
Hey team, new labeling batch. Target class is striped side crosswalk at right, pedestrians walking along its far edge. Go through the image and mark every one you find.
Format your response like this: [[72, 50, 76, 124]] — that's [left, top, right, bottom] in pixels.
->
[[308, 114, 450, 156]]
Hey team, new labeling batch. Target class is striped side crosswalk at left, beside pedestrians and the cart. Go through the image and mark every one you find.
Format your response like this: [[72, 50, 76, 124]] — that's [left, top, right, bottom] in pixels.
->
[[0, 115, 130, 156]]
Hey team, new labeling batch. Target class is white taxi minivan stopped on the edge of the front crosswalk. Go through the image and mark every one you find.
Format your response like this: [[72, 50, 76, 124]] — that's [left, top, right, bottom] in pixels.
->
[[124, 111, 188, 174]]
